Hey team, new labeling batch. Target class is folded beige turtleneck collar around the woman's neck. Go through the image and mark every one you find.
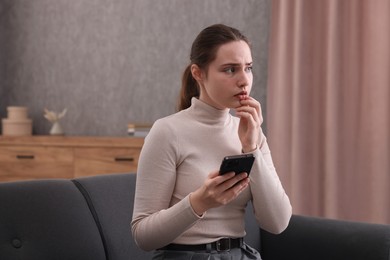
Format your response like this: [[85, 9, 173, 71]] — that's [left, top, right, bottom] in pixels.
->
[[188, 97, 231, 125]]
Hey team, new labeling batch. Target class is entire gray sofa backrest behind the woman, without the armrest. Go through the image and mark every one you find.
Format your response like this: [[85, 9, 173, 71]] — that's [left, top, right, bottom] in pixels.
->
[[0, 174, 260, 260]]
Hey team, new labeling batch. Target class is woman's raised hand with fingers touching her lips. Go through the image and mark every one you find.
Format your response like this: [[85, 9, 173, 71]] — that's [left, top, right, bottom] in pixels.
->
[[236, 96, 263, 152]]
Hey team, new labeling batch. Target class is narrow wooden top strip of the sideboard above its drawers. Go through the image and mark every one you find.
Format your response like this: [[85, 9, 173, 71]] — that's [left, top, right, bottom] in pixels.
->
[[0, 135, 144, 148]]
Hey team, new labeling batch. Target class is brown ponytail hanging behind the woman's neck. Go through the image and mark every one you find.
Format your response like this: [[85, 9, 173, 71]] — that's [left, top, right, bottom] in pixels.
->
[[178, 64, 200, 111]]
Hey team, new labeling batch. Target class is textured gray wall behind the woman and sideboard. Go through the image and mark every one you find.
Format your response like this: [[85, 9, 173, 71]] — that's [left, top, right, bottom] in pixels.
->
[[0, 0, 270, 136]]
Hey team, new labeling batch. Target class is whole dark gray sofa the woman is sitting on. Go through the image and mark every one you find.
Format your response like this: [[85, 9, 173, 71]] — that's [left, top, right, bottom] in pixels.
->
[[0, 174, 390, 260]]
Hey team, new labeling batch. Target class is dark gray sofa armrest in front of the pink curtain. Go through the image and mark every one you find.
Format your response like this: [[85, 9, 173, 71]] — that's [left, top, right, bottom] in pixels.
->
[[261, 215, 390, 260]]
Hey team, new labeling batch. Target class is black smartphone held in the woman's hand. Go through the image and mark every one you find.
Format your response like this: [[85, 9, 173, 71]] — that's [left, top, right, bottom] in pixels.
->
[[219, 154, 255, 175]]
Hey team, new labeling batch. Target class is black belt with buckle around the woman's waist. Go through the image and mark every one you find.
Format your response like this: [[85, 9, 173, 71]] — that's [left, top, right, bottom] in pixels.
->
[[159, 238, 244, 252]]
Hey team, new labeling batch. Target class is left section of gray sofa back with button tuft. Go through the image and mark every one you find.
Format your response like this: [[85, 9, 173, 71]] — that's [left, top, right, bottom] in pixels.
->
[[0, 180, 106, 260]]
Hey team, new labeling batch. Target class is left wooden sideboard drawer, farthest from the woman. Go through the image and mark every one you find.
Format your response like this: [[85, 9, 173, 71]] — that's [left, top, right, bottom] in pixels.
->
[[0, 146, 73, 181]]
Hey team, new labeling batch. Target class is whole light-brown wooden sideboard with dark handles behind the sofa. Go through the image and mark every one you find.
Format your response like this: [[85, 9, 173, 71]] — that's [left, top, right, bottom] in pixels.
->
[[0, 136, 144, 182]]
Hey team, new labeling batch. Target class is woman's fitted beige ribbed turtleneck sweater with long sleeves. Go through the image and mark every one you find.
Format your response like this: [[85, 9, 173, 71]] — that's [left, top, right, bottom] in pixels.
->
[[131, 98, 291, 250]]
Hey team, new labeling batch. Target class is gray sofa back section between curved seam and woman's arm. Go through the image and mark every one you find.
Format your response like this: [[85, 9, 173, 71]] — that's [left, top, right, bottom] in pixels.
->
[[74, 174, 152, 260]]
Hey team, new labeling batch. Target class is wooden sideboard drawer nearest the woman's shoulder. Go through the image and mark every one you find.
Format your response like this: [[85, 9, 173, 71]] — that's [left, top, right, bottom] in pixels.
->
[[74, 148, 140, 177]]
